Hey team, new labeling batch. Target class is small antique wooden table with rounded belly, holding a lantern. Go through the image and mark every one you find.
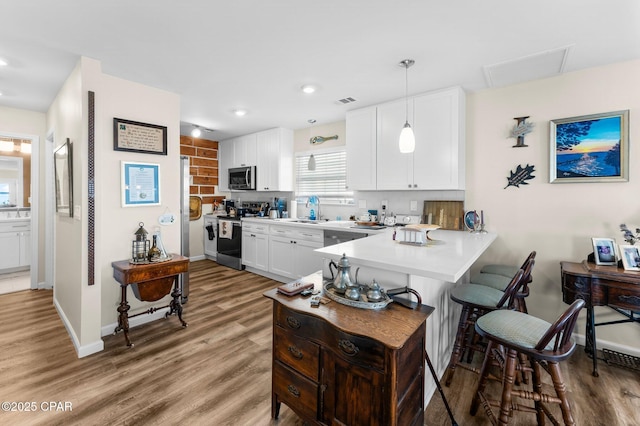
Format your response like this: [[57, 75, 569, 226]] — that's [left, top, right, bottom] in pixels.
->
[[111, 254, 189, 347]]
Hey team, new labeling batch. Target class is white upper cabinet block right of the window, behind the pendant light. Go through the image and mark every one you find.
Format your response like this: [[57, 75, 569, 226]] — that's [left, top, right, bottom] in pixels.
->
[[347, 87, 465, 190]]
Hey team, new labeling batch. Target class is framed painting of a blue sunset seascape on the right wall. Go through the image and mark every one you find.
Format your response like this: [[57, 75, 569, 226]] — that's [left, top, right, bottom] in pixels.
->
[[549, 110, 629, 183]]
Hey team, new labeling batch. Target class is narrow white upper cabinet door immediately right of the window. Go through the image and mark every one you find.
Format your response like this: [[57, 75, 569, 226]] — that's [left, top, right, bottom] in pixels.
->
[[346, 107, 377, 190]]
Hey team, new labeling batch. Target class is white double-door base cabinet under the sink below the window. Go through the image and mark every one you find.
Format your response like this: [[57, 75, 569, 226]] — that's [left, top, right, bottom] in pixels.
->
[[269, 225, 324, 279]]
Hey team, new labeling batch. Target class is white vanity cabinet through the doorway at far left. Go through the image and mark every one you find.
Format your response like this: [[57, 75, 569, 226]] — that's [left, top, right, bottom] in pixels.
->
[[0, 220, 31, 269]]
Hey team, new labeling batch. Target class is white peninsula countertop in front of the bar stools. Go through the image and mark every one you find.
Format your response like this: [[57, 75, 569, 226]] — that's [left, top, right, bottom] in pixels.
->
[[315, 228, 496, 282]]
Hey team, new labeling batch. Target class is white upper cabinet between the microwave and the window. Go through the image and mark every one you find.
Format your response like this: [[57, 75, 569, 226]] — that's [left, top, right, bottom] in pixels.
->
[[256, 128, 293, 191]]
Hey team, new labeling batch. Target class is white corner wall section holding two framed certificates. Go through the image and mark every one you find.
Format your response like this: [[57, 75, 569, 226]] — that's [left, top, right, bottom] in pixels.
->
[[47, 58, 180, 357]]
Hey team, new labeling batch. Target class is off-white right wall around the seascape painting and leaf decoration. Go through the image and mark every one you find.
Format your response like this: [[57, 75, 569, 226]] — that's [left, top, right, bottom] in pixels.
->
[[466, 61, 640, 354]]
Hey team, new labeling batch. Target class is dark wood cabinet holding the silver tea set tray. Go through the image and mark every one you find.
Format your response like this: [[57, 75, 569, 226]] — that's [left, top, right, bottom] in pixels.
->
[[265, 274, 433, 426]]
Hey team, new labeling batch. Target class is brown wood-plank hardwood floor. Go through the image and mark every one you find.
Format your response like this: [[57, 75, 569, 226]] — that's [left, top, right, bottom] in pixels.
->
[[0, 260, 640, 426]]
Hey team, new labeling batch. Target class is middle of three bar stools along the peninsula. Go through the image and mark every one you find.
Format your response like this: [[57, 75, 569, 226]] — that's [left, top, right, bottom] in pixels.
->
[[444, 259, 535, 386]]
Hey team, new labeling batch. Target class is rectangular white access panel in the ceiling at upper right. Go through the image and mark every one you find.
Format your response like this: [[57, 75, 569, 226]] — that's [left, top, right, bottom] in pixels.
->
[[484, 46, 571, 87]]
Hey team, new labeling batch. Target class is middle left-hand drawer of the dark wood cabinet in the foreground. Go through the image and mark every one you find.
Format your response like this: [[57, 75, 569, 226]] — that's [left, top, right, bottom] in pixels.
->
[[273, 326, 320, 381]]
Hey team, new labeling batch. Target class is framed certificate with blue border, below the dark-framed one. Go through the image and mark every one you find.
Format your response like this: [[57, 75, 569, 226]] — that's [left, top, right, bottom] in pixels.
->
[[121, 161, 160, 207]]
